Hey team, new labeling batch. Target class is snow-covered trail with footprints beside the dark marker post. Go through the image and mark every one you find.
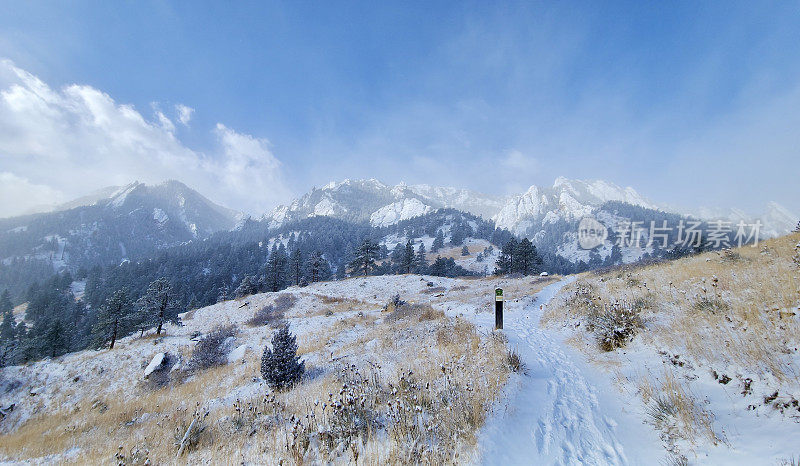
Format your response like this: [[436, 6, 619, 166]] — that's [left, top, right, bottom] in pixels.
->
[[468, 278, 664, 465]]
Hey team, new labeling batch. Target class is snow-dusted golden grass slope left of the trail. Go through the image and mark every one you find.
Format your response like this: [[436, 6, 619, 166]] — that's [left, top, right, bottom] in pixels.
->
[[0, 286, 508, 465]]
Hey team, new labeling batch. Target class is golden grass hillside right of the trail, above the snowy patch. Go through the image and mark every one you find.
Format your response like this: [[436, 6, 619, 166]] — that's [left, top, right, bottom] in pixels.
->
[[543, 234, 800, 381]]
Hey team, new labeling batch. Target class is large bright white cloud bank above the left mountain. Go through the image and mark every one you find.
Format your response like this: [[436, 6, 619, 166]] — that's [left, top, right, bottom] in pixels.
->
[[0, 60, 289, 216]]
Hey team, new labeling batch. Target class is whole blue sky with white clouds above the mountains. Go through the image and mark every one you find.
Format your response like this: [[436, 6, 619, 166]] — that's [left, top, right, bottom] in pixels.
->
[[0, 1, 800, 216]]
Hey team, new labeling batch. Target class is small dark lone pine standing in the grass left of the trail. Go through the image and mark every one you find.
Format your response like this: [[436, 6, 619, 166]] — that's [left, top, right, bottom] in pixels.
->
[[261, 324, 305, 390]]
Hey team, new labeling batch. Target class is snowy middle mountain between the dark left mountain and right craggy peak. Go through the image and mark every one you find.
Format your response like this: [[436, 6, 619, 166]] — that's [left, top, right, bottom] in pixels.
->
[[264, 179, 504, 228]]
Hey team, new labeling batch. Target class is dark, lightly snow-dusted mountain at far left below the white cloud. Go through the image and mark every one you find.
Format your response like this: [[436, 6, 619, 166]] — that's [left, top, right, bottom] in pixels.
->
[[0, 181, 240, 269]]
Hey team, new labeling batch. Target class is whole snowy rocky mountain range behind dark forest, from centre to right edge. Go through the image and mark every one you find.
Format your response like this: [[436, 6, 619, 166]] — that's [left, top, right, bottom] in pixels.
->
[[264, 177, 798, 237]]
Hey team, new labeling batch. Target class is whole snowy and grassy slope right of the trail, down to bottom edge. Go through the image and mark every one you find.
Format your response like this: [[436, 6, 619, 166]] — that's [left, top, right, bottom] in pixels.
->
[[543, 234, 800, 465]]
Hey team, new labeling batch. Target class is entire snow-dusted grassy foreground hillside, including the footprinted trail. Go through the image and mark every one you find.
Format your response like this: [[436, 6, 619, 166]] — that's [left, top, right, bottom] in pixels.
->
[[0, 231, 800, 465]]
